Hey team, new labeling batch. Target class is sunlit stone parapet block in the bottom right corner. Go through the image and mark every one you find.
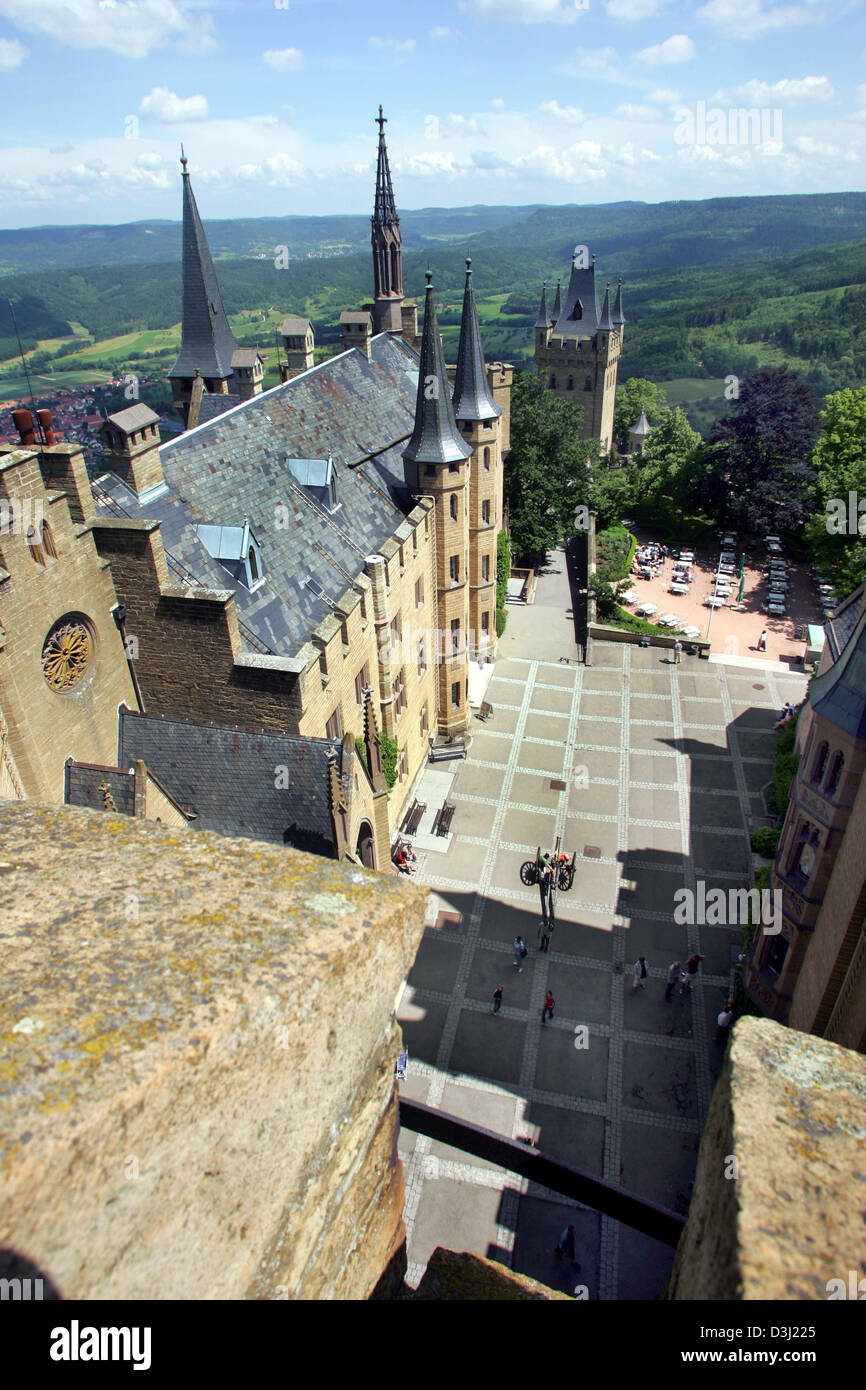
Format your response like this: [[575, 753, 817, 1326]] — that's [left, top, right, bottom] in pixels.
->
[[667, 1017, 866, 1300]]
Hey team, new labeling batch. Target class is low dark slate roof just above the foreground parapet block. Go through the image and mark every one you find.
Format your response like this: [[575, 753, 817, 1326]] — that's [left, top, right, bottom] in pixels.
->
[[120, 709, 341, 856]]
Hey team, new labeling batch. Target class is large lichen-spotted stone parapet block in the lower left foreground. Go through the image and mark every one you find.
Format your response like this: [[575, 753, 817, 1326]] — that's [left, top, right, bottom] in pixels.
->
[[0, 802, 424, 1300]]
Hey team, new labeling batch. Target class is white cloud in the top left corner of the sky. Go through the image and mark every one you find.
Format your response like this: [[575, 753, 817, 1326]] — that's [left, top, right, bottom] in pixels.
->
[[0, 0, 214, 58]]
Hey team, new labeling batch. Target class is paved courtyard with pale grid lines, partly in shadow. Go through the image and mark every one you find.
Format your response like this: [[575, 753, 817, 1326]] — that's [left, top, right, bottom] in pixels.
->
[[399, 557, 805, 1298]]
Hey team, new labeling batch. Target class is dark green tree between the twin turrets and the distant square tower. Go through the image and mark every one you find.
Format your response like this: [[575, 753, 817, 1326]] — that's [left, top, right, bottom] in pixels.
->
[[505, 371, 598, 560]]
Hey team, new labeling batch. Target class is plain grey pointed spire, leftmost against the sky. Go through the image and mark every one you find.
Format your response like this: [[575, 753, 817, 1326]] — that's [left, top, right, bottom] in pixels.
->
[[168, 149, 238, 423]]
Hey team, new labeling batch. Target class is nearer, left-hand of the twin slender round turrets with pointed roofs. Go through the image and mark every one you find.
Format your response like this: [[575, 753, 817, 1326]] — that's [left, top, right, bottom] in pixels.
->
[[403, 271, 473, 734]]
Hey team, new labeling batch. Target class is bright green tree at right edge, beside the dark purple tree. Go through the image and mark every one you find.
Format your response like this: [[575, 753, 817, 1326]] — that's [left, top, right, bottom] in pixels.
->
[[806, 386, 866, 594]]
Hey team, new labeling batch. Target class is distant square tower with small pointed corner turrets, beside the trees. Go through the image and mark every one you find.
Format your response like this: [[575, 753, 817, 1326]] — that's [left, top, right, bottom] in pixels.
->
[[535, 246, 626, 453]]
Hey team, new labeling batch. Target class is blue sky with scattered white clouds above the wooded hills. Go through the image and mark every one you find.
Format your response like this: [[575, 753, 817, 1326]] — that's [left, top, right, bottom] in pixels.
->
[[0, 0, 866, 228]]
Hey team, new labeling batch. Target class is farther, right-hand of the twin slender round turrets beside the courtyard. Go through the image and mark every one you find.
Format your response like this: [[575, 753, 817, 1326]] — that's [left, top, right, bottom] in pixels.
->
[[453, 259, 502, 660]]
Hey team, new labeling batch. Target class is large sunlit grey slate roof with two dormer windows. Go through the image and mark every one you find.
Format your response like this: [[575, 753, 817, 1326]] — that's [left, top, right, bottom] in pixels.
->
[[99, 334, 419, 656]]
